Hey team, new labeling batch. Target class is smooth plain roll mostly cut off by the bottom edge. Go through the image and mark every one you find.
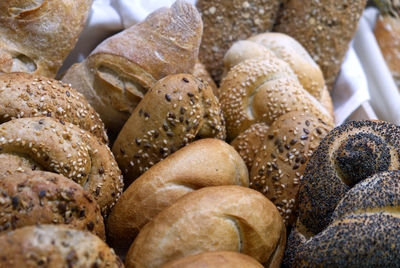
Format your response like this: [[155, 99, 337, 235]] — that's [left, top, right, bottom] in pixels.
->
[[161, 251, 264, 268]]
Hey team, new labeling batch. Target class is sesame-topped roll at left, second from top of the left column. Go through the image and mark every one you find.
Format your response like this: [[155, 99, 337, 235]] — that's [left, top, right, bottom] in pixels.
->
[[0, 117, 123, 216]]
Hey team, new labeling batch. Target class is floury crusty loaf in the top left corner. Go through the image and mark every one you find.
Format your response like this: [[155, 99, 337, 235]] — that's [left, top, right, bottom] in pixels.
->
[[0, 0, 92, 78]]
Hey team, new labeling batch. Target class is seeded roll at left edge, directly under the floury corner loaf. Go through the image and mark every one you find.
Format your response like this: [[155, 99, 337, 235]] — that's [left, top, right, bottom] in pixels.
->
[[0, 73, 108, 143]]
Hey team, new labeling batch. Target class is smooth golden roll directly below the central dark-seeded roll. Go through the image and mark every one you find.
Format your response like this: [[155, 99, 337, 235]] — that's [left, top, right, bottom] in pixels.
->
[[107, 139, 249, 249]]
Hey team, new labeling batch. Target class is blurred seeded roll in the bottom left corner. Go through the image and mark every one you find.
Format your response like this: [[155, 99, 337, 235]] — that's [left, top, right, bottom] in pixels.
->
[[0, 225, 123, 268]]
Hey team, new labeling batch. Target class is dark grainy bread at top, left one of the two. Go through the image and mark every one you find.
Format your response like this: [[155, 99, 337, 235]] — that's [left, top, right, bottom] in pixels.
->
[[196, 0, 282, 84]]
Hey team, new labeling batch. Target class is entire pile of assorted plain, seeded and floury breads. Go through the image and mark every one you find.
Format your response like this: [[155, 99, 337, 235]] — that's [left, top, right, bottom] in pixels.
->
[[0, 0, 386, 267]]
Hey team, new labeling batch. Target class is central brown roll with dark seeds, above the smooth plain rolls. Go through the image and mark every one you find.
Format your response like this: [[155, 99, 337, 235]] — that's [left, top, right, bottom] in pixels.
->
[[113, 74, 225, 185]]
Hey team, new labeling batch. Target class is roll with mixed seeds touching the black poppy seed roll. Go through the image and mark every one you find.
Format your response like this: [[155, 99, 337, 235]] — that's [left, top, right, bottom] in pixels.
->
[[250, 112, 332, 226]]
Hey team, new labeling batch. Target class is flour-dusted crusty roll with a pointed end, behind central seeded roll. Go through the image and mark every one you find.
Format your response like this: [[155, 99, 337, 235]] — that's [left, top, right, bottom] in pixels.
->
[[63, 0, 203, 135]]
